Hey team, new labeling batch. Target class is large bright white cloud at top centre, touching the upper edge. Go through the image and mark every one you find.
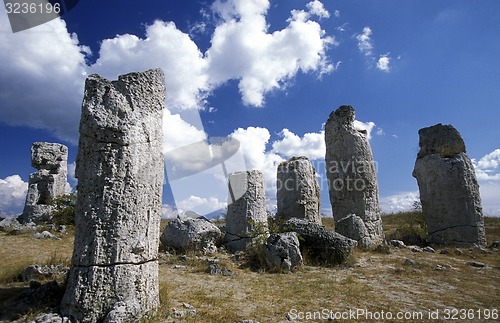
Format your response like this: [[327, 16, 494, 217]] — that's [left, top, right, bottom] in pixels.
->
[[206, 0, 333, 107]]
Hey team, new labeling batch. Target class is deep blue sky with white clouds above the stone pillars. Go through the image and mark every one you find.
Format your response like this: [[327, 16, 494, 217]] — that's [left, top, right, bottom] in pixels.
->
[[0, 0, 500, 216]]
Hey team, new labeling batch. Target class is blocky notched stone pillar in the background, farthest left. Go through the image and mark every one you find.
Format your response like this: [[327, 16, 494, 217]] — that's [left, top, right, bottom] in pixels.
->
[[18, 142, 68, 223]]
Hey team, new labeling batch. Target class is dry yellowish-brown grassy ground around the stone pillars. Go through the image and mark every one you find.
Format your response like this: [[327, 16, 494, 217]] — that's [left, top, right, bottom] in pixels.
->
[[0, 214, 500, 323]]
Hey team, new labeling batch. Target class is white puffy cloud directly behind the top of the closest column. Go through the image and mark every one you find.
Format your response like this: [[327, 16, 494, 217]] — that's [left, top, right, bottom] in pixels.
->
[[89, 20, 209, 109]]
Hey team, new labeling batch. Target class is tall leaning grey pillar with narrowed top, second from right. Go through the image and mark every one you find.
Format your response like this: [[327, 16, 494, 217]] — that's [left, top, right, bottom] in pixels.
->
[[325, 105, 384, 247]]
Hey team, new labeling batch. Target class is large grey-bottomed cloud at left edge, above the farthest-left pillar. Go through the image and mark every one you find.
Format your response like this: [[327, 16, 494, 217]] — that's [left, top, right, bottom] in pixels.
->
[[0, 6, 89, 142]]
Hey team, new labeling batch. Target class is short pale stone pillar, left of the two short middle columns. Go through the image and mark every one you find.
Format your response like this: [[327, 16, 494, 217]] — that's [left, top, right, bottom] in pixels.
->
[[224, 170, 267, 252]]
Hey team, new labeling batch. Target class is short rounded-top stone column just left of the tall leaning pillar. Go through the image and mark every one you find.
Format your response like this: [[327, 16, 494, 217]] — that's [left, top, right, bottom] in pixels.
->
[[276, 157, 321, 224]]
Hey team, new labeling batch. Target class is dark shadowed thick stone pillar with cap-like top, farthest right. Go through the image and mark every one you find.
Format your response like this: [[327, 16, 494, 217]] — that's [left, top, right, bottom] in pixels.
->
[[413, 124, 486, 246]]
